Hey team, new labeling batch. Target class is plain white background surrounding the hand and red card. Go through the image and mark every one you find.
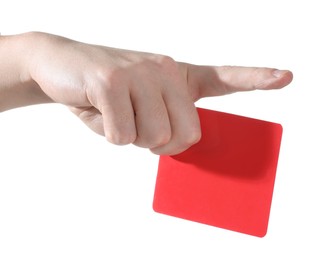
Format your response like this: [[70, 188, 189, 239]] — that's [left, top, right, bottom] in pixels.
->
[[0, 0, 328, 260]]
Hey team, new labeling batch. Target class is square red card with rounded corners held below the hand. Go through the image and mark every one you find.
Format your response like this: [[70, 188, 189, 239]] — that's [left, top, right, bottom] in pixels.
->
[[153, 108, 282, 237]]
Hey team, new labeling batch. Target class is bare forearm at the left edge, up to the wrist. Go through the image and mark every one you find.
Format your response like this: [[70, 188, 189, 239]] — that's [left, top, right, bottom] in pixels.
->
[[0, 33, 51, 112]]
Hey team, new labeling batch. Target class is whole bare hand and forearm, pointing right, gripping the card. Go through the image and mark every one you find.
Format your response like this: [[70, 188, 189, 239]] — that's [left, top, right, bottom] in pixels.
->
[[0, 32, 293, 155]]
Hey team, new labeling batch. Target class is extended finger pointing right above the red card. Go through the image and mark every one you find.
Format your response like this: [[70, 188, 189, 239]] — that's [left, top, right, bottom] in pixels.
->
[[180, 63, 293, 101]]
